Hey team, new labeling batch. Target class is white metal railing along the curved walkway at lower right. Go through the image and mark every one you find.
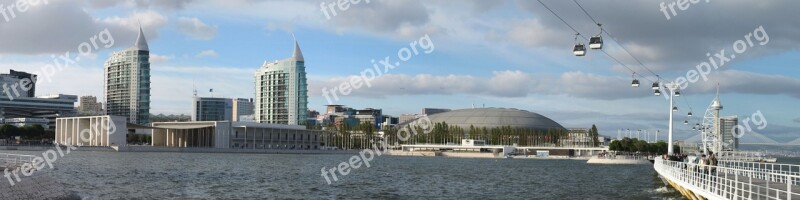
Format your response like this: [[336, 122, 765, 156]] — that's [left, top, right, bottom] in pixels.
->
[[653, 158, 800, 200]]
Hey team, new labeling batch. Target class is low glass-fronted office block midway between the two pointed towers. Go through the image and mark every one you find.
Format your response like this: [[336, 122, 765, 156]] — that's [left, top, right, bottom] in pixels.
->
[[192, 96, 233, 121]]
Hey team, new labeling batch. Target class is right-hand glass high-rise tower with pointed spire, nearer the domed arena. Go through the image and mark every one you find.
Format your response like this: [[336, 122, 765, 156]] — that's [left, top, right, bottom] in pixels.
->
[[254, 41, 308, 125]]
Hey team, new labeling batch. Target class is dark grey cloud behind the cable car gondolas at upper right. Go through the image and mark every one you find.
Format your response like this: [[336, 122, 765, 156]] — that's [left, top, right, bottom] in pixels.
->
[[512, 0, 800, 70]]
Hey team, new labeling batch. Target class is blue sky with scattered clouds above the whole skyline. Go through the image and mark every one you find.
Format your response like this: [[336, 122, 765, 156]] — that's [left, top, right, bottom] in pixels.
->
[[0, 0, 800, 143]]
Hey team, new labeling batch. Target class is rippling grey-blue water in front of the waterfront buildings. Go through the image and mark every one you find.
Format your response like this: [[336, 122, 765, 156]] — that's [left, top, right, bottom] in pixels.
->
[[3, 151, 681, 199]]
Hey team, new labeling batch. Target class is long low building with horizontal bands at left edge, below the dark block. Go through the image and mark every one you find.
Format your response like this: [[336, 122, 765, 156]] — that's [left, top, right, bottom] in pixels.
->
[[0, 94, 78, 127]]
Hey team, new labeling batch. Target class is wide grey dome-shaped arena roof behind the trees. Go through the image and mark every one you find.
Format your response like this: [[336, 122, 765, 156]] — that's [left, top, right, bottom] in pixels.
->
[[428, 108, 564, 131]]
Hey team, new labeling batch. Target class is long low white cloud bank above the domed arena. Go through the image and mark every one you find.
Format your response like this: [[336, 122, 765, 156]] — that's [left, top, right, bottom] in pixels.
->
[[309, 70, 800, 100]]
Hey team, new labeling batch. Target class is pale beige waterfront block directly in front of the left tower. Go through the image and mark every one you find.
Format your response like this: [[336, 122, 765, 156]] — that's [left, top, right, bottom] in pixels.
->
[[55, 115, 127, 147]]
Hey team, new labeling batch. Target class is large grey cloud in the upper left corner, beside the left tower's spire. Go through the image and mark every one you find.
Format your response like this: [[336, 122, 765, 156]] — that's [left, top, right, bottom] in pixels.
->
[[0, 1, 167, 55]]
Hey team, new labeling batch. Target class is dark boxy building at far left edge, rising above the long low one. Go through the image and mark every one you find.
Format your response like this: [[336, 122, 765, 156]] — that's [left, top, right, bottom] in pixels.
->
[[0, 69, 36, 98]]
